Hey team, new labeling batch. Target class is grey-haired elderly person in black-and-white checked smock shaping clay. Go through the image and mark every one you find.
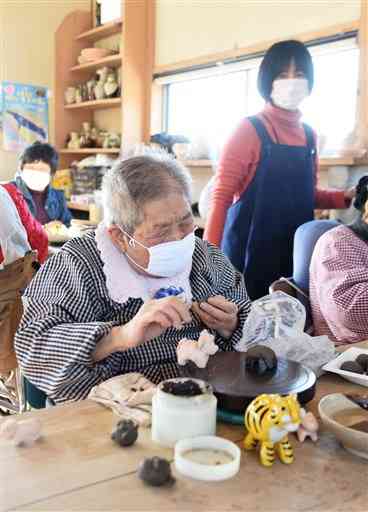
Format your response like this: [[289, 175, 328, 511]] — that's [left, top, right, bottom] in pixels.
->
[[15, 153, 250, 403]]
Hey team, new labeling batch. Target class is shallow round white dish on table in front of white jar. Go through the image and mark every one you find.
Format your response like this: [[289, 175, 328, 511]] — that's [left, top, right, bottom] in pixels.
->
[[175, 436, 241, 482]]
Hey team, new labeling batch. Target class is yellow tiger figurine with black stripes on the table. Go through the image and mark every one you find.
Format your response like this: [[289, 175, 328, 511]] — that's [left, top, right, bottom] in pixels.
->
[[244, 394, 304, 466]]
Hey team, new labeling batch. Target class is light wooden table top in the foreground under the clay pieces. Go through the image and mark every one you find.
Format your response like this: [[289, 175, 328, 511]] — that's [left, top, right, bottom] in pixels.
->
[[0, 346, 368, 512]]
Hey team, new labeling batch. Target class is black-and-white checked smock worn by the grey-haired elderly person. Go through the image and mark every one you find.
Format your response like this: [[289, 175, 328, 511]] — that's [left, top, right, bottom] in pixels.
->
[[15, 232, 250, 402]]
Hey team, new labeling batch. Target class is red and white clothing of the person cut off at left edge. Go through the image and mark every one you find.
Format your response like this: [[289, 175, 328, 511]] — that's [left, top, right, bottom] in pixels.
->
[[0, 183, 48, 267]]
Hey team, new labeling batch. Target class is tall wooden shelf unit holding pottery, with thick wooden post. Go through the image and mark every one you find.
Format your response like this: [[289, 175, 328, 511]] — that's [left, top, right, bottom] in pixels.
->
[[55, 0, 155, 169]]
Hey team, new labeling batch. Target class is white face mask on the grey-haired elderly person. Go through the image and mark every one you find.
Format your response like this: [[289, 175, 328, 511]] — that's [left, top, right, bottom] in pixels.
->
[[119, 226, 195, 277]]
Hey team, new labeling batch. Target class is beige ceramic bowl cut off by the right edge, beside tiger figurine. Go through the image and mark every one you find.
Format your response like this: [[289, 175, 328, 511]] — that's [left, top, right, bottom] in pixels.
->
[[318, 393, 368, 460]]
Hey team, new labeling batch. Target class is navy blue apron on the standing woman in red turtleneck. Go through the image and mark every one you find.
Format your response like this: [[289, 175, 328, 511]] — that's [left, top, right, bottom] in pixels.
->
[[221, 117, 316, 300]]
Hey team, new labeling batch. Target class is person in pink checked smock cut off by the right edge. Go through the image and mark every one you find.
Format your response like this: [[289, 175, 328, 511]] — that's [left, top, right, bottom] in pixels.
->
[[310, 176, 368, 344]]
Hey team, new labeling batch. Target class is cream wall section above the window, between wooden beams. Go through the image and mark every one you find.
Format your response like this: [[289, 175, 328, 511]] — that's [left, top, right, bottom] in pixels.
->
[[155, 0, 360, 66]]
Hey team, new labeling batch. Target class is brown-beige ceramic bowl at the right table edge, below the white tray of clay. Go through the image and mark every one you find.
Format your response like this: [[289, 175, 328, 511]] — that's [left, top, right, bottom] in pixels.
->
[[318, 393, 368, 460]]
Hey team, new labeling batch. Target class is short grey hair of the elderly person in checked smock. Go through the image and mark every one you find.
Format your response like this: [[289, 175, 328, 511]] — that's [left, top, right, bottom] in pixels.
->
[[102, 151, 192, 234]]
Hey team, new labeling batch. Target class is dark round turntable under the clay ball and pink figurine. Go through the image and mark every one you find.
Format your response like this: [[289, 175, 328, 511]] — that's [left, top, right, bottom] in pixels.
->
[[181, 352, 316, 414]]
